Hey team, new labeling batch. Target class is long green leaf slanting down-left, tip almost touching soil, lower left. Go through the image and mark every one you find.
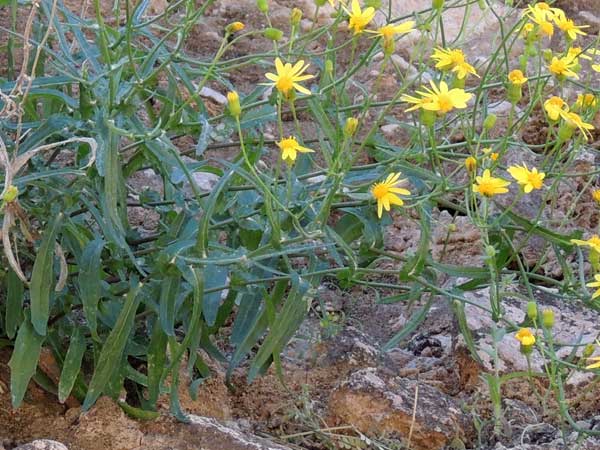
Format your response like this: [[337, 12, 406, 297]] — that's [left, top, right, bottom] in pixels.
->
[[83, 279, 141, 410]]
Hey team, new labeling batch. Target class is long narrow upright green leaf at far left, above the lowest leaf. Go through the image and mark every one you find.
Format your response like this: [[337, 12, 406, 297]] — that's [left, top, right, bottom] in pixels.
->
[[29, 213, 64, 336]]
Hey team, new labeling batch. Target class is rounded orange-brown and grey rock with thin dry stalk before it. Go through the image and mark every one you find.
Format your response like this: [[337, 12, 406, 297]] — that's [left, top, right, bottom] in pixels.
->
[[329, 368, 471, 450]]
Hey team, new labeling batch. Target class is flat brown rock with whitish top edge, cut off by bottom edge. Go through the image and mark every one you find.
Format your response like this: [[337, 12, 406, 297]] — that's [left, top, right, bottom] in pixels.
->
[[138, 416, 291, 450]]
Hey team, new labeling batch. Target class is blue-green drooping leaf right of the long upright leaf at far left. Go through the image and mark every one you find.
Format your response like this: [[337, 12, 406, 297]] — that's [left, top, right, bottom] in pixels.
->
[[77, 239, 104, 340]]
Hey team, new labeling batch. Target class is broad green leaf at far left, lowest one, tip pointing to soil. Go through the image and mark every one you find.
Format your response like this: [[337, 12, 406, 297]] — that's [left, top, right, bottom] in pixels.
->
[[8, 319, 44, 408]]
